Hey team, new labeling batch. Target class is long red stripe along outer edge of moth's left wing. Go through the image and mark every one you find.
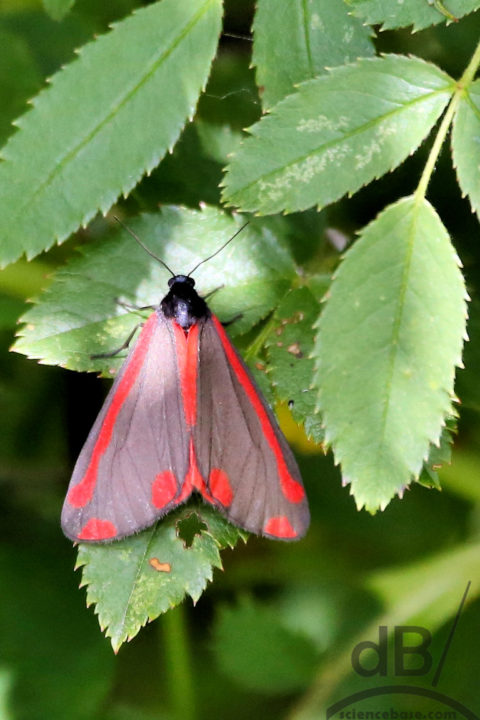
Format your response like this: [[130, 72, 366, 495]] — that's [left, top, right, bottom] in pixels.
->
[[67, 313, 157, 506]]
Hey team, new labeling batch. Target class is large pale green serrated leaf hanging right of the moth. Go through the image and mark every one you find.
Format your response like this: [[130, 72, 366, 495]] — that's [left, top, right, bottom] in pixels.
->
[[315, 197, 466, 511]]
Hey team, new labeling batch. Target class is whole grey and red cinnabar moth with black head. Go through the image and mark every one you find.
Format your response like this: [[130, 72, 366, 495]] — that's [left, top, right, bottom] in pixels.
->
[[62, 228, 309, 542]]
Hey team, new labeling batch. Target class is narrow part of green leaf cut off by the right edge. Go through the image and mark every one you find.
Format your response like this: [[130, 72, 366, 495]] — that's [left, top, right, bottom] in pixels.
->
[[452, 80, 480, 216]]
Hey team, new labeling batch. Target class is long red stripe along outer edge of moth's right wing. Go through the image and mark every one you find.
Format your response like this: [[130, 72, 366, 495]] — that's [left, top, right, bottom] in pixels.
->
[[212, 315, 305, 506]]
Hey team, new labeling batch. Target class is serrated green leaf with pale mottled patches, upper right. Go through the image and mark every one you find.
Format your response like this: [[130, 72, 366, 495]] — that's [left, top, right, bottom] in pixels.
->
[[224, 55, 453, 214]]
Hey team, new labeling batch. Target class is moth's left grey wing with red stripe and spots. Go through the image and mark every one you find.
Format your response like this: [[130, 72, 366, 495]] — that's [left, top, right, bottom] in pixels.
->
[[62, 310, 189, 542]]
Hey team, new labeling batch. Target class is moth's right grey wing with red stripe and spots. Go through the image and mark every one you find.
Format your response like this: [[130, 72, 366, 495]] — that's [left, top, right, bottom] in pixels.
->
[[194, 316, 310, 540]]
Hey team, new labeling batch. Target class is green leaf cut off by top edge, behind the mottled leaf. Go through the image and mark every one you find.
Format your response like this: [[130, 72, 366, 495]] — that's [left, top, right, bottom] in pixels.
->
[[253, 0, 375, 108]]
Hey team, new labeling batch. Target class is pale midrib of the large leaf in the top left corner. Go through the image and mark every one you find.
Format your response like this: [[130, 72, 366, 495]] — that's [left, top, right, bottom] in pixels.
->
[[10, 0, 215, 223]]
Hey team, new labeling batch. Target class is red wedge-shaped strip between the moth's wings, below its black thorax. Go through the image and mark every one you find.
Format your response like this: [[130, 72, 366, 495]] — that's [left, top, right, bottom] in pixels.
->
[[173, 322, 198, 427]]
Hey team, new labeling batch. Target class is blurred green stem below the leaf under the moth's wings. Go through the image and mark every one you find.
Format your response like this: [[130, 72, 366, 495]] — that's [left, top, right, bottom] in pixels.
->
[[162, 604, 196, 720]]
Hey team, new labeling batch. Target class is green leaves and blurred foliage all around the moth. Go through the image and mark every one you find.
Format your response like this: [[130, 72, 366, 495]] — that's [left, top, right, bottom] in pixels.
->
[[0, 0, 480, 720]]
